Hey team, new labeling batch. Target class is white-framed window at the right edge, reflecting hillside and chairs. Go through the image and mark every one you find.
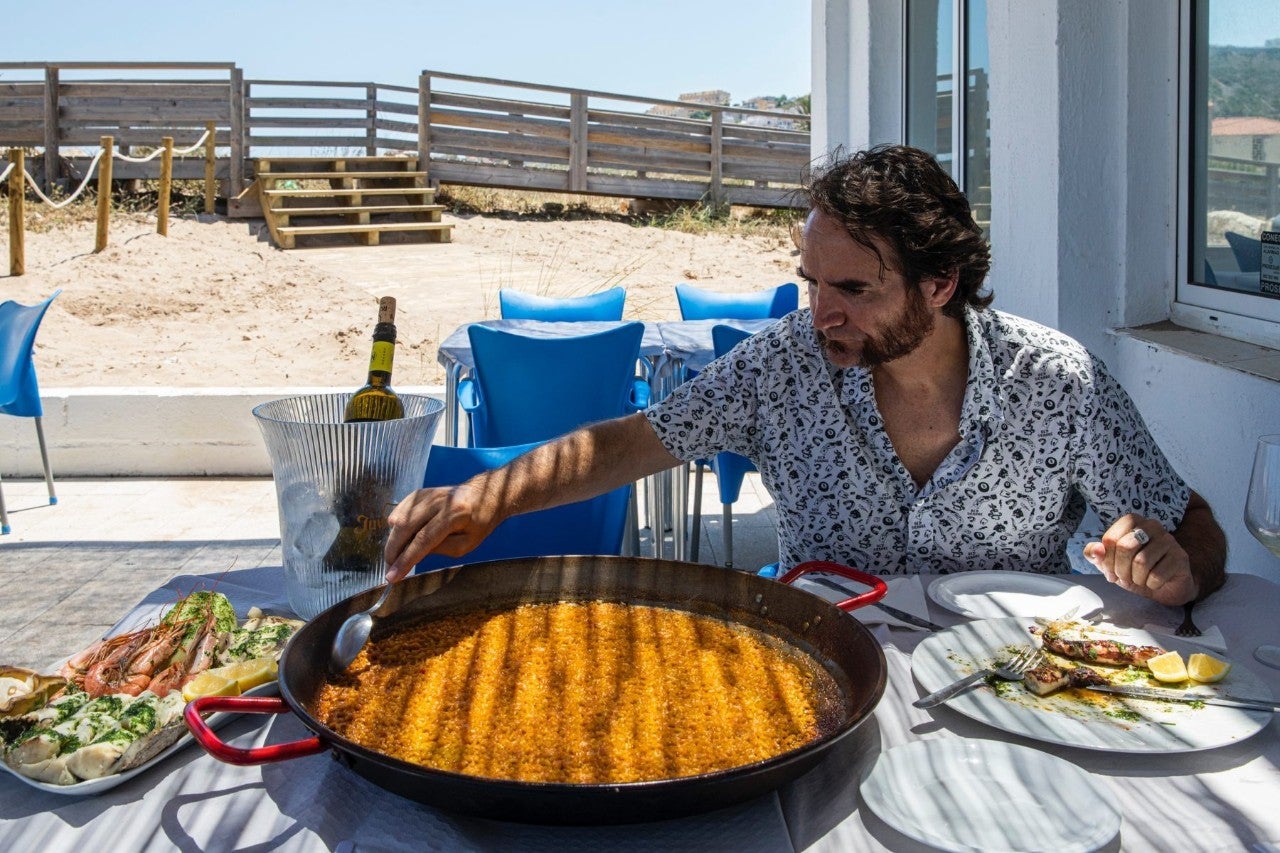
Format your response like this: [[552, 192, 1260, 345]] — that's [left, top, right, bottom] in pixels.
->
[[1174, 0, 1280, 347]]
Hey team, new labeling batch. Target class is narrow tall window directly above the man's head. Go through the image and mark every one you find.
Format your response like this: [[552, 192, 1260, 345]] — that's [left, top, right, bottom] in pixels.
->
[[905, 0, 991, 229]]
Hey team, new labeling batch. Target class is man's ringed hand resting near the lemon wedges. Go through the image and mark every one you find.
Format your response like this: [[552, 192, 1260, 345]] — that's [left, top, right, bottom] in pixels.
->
[[1084, 515, 1199, 605]]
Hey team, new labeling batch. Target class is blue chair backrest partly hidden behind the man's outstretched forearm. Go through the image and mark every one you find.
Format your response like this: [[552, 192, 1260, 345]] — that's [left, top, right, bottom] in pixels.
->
[[413, 442, 632, 571]]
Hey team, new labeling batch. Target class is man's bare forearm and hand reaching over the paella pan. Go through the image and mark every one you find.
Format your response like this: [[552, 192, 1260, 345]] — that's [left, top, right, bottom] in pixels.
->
[[384, 414, 680, 581]]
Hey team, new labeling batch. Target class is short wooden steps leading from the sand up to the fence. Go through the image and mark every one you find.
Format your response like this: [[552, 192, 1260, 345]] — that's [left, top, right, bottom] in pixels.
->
[[253, 156, 453, 248]]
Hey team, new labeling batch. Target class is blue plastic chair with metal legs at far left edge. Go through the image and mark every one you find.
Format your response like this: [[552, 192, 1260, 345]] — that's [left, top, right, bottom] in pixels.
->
[[0, 291, 61, 534]]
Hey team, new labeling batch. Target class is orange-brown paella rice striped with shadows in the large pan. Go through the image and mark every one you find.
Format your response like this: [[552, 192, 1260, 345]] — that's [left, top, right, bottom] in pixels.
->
[[316, 601, 838, 784]]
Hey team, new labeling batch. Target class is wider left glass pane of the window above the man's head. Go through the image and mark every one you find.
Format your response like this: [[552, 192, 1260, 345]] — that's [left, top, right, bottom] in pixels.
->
[[906, 0, 955, 174]]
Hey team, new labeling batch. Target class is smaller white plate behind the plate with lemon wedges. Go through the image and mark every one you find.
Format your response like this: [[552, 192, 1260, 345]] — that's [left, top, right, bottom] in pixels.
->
[[929, 571, 1102, 619]]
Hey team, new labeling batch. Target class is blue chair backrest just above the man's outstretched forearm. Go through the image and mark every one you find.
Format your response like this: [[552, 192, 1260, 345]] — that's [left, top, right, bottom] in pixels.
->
[[468, 323, 644, 447]]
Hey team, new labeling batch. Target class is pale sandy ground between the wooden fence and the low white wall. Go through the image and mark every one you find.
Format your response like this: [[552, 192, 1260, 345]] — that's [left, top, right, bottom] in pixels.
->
[[0, 214, 797, 388]]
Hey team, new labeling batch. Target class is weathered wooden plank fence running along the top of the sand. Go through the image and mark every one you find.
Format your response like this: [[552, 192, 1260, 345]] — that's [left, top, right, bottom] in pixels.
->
[[0, 63, 810, 206]]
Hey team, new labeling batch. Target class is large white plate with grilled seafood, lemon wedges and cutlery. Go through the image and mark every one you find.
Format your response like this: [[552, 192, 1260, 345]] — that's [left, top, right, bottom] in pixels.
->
[[911, 617, 1274, 753]]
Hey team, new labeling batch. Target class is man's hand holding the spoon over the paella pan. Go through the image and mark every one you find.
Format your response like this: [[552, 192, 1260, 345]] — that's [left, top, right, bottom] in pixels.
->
[[384, 482, 502, 583]]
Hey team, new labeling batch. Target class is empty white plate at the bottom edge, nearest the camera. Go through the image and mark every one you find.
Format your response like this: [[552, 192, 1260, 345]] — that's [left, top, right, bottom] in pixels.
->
[[861, 739, 1120, 853]]
